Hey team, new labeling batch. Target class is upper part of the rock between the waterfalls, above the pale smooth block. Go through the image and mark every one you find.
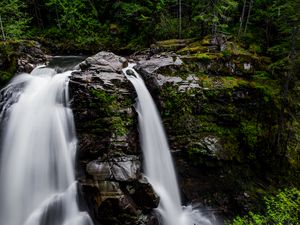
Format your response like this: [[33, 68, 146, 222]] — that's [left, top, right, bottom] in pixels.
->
[[69, 52, 137, 161]]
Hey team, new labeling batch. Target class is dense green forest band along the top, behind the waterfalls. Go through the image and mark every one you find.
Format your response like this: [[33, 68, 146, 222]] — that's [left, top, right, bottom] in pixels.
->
[[0, 0, 300, 53]]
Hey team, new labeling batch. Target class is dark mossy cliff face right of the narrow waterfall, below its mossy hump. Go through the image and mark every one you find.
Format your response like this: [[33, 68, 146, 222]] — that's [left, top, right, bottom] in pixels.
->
[[137, 51, 280, 216]]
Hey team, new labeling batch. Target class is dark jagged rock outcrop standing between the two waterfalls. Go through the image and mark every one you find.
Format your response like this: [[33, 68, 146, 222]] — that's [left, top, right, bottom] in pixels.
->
[[69, 52, 159, 225]]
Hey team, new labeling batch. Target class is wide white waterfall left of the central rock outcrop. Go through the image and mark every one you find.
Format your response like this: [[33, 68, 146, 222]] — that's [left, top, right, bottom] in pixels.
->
[[0, 67, 93, 225]]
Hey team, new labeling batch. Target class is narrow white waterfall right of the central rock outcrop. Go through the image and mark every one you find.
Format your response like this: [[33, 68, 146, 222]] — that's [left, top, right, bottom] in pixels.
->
[[123, 64, 212, 225]]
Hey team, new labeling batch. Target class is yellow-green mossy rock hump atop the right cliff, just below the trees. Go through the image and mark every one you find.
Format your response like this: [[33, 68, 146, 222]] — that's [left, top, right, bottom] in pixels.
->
[[177, 36, 270, 77]]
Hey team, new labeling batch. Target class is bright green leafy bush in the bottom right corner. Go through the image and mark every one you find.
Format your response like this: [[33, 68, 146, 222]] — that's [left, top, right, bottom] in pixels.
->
[[231, 188, 300, 225]]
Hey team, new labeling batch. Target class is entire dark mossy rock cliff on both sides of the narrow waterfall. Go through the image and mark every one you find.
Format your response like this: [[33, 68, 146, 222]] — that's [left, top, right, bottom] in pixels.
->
[[70, 38, 298, 224]]
